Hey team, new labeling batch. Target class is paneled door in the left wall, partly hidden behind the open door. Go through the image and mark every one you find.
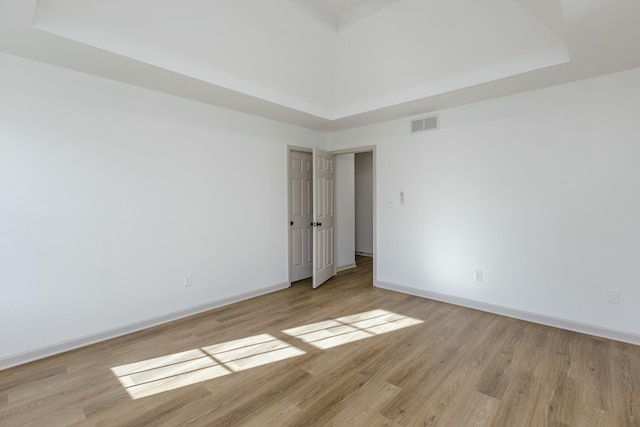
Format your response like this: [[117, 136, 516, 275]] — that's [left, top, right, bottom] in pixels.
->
[[289, 151, 313, 282]]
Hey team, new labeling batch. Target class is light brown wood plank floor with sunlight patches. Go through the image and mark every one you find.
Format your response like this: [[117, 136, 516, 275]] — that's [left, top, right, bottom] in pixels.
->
[[0, 258, 640, 427]]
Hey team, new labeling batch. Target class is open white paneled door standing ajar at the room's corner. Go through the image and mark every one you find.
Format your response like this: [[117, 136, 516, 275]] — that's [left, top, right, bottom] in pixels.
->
[[313, 148, 336, 288]]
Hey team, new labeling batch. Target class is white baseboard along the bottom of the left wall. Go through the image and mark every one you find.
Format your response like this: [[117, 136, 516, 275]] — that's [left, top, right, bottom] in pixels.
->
[[0, 283, 289, 371]]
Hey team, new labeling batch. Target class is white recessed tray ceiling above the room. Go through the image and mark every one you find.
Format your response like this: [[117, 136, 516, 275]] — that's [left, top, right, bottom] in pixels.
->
[[0, 0, 640, 131]]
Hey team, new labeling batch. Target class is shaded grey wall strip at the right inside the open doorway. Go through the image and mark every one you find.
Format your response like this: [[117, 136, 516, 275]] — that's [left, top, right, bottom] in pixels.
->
[[355, 151, 373, 255]]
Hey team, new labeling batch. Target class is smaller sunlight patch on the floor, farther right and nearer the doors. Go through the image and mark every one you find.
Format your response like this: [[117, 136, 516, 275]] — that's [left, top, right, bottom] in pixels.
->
[[282, 310, 424, 350]]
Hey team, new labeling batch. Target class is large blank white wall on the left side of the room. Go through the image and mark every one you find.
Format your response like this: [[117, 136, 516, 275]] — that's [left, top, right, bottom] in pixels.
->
[[0, 50, 324, 366]]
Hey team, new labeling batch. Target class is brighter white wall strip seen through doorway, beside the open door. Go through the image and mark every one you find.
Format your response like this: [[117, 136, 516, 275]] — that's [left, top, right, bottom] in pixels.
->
[[335, 153, 356, 270]]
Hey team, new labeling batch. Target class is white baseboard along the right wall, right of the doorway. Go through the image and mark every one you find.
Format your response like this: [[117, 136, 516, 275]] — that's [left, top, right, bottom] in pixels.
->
[[374, 281, 640, 345]]
